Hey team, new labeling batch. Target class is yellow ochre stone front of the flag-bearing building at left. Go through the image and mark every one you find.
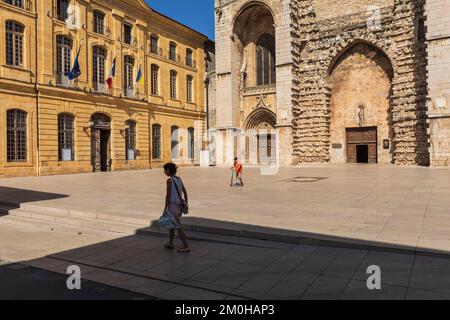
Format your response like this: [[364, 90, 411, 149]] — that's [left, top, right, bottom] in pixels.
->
[[0, 0, 207, 177]]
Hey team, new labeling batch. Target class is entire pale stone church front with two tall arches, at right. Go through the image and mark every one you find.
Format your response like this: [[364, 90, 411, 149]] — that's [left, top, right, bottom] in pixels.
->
[[212, 0, 450, 166]]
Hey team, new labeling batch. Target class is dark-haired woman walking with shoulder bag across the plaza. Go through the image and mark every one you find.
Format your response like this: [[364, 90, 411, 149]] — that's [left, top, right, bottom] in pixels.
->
[[164, 163, 191, 253]]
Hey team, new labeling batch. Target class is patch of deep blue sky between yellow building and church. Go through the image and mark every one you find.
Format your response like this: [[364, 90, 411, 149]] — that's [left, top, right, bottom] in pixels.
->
[[145, 0, 214, 40]]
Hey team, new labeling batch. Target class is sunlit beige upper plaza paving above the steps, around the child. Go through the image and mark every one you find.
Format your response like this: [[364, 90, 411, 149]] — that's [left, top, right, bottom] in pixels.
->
[[0, 165, 450, 253]]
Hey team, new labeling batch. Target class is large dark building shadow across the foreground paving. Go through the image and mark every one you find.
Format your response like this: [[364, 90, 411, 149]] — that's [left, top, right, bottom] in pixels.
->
[[0, 217, 450, 300]]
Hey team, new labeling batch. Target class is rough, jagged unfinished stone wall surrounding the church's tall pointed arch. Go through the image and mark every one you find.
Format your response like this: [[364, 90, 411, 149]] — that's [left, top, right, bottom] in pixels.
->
[[291, 0, 429, 165]]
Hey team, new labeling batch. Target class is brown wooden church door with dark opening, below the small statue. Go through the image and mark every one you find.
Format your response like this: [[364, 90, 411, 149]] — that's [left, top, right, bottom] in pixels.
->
[[346, 127, 378, 163]]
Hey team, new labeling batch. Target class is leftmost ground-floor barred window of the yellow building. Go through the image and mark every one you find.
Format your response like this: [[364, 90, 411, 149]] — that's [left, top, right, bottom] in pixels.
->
[[6, 109, 27, 162]]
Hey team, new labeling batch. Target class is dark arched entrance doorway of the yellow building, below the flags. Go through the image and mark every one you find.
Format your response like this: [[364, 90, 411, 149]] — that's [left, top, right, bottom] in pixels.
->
[[91, 113, 111, 172]]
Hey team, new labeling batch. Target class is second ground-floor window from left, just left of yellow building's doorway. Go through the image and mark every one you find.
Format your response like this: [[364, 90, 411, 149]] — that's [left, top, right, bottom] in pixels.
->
[[58, 113, 75, 161]]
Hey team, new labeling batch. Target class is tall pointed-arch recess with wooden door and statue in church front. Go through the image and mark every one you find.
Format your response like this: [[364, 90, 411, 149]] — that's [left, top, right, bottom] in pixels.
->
[[328, 43, 393, 163]]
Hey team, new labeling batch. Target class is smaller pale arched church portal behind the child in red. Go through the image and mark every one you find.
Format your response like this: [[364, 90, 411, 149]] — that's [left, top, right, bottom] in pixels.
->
[[244, 107, 277, 165]]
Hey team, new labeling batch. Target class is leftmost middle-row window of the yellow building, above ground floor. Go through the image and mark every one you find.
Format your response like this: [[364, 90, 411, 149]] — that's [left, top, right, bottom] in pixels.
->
[[6, 21, 25, 67]]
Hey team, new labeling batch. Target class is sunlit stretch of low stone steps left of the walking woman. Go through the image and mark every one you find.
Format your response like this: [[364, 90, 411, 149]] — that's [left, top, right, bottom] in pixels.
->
[[9, 209, 148, 234]]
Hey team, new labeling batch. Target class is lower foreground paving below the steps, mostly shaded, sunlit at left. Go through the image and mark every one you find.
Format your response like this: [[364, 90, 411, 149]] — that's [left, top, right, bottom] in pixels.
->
[[0, 216, 450, 300]]
